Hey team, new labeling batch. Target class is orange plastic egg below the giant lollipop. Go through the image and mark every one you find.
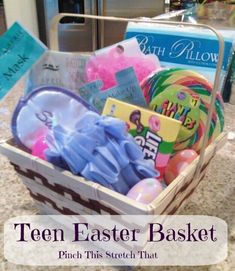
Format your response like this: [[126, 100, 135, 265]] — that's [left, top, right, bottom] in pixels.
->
[[164, 149, 198, 184]]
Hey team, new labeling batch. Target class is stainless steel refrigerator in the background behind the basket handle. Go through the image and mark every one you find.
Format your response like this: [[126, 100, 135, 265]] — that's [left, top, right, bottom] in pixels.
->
[[36, 0, 165, 52]]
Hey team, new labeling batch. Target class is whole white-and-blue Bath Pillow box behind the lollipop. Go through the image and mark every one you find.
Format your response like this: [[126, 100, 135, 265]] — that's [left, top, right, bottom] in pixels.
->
[[125, 22, 234, 90]]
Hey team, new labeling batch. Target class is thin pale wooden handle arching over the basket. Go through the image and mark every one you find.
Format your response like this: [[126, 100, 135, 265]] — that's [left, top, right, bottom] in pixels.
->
[[49, 13, 224, 182]]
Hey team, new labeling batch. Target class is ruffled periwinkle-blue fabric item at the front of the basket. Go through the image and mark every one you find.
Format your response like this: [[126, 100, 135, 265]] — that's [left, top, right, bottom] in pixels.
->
[[45, 111, 159, 194]]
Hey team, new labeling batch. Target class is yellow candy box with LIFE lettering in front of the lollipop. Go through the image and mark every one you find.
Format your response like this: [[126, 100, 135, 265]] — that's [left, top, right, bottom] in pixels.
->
[[103, 98, 181, 177]]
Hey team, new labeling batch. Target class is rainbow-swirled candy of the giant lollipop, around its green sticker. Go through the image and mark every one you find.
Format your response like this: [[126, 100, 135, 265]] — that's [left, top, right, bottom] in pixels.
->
[[141, 68, 224, 151]]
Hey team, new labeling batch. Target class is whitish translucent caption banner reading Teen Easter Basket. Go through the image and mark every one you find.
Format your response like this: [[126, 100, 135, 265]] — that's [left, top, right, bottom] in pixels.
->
[[4, 216, 228, 270]]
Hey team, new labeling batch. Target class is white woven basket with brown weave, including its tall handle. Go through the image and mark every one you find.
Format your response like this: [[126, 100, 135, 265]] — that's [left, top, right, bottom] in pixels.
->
[[0, 13, 226, 215]]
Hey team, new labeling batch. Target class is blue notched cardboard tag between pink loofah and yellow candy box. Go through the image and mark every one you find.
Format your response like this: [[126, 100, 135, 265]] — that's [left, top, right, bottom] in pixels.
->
[[78, 67, 147, 113]]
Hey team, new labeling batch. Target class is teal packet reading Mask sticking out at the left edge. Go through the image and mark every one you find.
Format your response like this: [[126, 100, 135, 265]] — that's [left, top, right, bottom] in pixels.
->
[[0, 23, 47, 100]]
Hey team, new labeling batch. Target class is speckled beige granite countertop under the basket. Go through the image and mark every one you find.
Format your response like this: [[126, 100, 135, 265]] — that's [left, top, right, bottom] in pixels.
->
[[0, 83, 235, 271]]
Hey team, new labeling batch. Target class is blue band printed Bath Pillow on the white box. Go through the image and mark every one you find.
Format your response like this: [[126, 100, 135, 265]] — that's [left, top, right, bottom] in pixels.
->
[[125, 29, 232, 70]]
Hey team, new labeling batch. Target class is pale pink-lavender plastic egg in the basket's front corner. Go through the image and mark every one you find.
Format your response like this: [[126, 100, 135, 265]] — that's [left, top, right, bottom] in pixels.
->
[[127, 178, 163, 204]]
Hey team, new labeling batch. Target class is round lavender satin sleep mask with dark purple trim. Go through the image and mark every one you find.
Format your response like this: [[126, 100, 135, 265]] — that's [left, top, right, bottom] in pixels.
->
[[11, 86, 96, 150]]
